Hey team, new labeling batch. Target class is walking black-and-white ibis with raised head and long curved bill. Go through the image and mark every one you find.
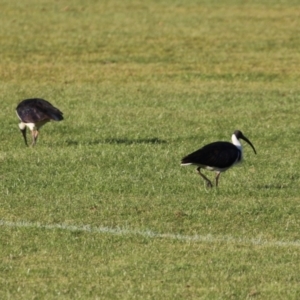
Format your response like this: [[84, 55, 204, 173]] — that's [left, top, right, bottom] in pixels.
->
[[181, 130, 256, 187]]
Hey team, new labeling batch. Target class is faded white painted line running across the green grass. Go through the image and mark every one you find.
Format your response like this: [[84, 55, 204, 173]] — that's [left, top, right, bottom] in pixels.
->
[[0, 220, 300, 247]]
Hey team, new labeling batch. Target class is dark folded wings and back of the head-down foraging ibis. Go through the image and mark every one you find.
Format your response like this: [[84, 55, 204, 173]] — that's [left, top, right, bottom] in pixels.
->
[[16, 98, 63, 123]]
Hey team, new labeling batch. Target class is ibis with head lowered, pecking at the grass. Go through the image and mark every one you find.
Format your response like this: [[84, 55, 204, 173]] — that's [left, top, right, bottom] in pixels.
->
[[16, 98, 63, 146]]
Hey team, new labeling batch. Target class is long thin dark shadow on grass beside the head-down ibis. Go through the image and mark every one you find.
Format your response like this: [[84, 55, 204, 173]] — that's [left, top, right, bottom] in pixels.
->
[[65, 137, 167, 146]]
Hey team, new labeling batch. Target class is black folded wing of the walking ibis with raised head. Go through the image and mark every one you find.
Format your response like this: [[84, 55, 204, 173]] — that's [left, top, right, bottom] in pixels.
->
[[181, 142, 240, 169]]
